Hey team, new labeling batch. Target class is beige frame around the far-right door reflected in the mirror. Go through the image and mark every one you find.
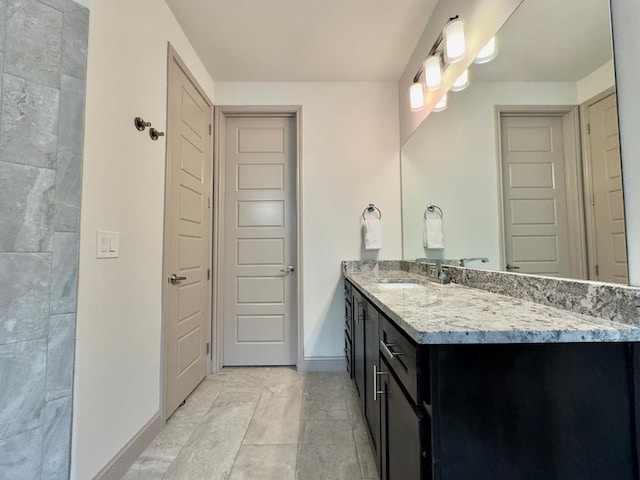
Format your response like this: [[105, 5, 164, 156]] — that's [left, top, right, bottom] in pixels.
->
[[580, 87, 629, 279]]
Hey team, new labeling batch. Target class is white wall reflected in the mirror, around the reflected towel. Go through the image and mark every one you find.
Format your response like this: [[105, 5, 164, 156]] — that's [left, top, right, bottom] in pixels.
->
[[402, 82, 576, 269]]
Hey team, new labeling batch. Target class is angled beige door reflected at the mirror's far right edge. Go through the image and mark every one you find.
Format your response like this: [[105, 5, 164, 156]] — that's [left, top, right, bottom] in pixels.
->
[[588, 94, 628, 284]]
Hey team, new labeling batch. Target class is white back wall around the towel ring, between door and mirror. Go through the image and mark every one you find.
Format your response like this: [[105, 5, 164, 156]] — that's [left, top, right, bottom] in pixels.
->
[[215, 82, 402, 358]]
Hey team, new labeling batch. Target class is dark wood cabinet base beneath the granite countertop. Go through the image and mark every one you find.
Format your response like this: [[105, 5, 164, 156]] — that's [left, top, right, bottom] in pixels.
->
[[345, 282, 640, 480]]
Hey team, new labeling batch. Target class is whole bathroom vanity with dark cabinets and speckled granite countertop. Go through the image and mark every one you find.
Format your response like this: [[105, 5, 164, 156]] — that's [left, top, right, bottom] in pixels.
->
[[344, 262, 640, 480]]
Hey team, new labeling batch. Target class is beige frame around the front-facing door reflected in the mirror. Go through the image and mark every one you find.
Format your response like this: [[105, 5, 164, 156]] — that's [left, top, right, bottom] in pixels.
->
[[494, 105, 588, 280]]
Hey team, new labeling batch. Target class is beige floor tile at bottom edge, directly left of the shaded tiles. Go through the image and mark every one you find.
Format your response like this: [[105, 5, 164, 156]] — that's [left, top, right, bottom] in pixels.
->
[[229, 445, 298, 480]]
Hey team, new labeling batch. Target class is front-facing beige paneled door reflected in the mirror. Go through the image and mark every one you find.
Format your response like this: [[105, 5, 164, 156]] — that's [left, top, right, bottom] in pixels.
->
[[500, 115, 572, 277]]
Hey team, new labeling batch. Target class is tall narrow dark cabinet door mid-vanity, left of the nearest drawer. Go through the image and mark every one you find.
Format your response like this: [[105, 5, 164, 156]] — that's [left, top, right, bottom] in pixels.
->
[[364, 302, 380, 462]]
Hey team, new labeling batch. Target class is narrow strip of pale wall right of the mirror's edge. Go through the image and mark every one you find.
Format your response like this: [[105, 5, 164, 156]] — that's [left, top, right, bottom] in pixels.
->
[[611, 0, 640, 286]]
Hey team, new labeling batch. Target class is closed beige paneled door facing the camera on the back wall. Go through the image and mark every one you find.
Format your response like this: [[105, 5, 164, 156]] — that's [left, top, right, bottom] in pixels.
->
[[223, 116, 297, 365]]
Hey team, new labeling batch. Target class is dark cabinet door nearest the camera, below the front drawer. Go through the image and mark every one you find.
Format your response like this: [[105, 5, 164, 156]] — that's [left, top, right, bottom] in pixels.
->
[[379, 357, 430, 480]]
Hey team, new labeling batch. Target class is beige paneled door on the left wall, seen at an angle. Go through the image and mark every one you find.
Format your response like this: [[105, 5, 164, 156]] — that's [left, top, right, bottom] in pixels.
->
[[163, 47, 213, 418]]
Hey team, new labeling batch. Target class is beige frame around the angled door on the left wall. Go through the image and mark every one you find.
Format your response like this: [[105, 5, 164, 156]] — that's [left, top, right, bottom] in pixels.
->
[[160, 42, 215, 425]]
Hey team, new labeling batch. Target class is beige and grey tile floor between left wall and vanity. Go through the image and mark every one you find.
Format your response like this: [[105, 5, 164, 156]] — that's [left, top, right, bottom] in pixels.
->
[[123, 367, 378, 480]]
